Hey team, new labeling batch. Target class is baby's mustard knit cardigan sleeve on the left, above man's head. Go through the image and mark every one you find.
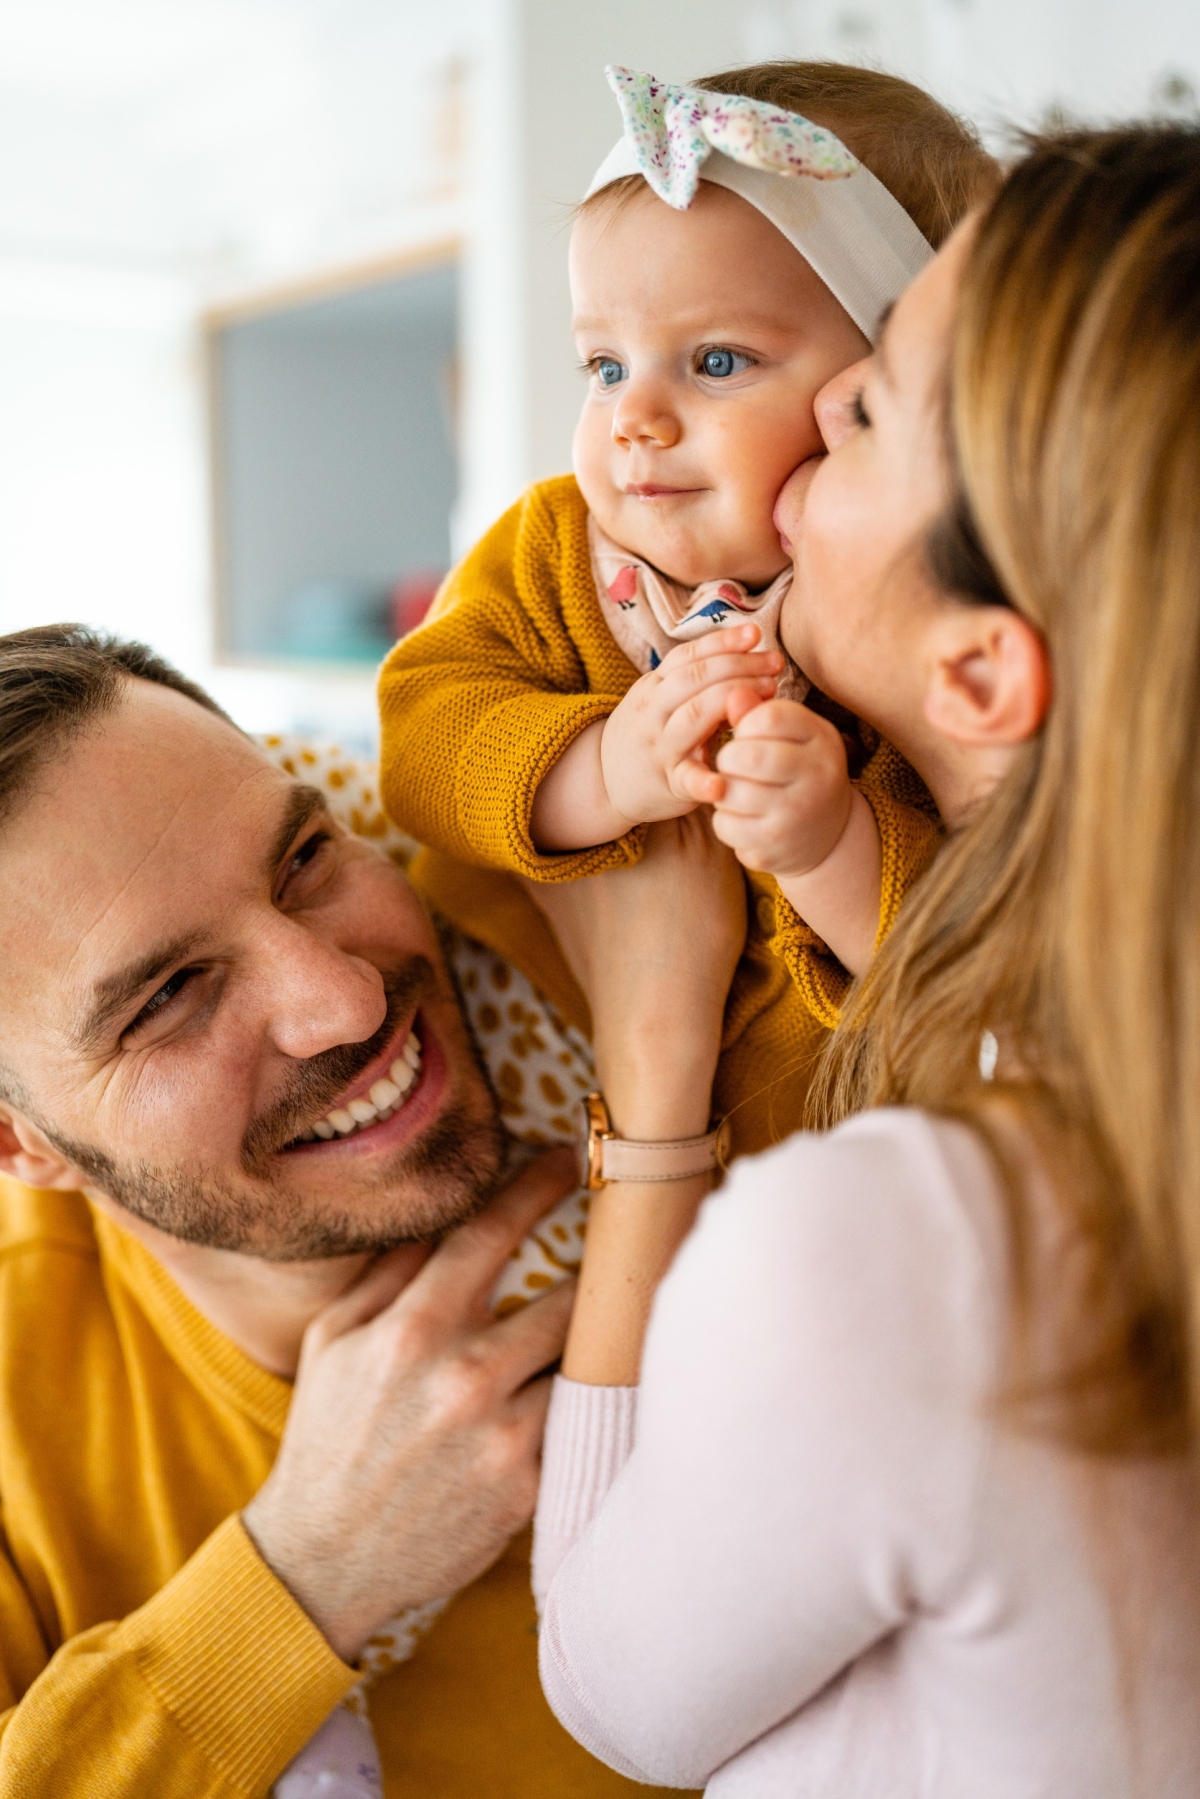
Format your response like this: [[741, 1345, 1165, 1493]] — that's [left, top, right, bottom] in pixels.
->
[[380, 482, 644, 882]]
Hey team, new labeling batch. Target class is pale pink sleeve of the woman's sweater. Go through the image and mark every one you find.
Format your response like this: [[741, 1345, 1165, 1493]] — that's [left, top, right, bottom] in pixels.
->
[[540, 1112, 1000, 1790]]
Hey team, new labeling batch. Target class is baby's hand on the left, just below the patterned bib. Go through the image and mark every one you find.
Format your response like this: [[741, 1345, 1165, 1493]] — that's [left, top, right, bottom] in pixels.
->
[[601, 624, 784, 823]]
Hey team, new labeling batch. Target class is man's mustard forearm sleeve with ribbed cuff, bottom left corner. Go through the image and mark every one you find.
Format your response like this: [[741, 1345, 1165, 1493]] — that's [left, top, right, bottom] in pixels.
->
[[0, 1518, 356, 1799]]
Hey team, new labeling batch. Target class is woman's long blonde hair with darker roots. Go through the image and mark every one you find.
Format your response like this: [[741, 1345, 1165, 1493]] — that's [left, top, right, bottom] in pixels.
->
[[822, 126, 1200, 1454]]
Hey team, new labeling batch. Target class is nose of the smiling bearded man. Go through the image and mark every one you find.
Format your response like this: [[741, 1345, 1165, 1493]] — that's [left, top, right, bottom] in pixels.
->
[[259, 916, 387, 1061]]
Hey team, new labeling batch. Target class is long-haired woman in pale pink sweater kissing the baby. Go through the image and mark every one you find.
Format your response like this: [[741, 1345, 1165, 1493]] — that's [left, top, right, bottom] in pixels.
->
[[538, 130, 1200, 1799]]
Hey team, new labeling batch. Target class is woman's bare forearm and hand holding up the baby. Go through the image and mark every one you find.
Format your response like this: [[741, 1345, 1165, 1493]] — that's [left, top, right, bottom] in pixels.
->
[[531, 813, 745, 1387]]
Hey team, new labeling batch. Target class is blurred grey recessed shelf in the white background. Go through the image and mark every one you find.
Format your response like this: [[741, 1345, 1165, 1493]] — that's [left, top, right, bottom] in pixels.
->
[[207, 246, 459, 673]]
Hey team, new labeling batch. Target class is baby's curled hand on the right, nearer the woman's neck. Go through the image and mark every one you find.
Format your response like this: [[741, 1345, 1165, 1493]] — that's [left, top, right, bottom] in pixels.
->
[[676, 694, 855, 878]]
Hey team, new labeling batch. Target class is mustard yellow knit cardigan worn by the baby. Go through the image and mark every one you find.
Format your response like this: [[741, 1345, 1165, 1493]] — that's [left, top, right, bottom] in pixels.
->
[[380, 475, 937, 1153]]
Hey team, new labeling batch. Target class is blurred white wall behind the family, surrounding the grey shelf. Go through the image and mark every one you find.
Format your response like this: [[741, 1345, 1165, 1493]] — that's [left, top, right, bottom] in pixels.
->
[[0, 0, 1200, 736]]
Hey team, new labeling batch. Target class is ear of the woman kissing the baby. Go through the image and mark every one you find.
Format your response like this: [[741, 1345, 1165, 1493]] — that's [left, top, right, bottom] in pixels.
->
[[925, 601, 1051, 748]]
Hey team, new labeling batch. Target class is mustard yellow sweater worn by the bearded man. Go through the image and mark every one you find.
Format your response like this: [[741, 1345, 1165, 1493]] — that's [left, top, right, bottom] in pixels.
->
[[0, 1180, 666, 1799]]
